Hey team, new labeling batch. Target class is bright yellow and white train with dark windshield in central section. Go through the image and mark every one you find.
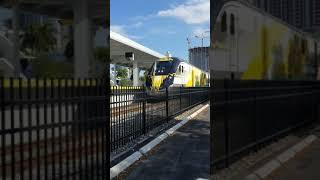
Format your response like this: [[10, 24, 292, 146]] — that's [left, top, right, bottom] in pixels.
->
[[146, 57, 209, 91]]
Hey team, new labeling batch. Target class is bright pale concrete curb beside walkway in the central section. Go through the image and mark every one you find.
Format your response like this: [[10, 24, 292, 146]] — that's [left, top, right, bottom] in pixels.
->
[[110, 104, 209, 179]]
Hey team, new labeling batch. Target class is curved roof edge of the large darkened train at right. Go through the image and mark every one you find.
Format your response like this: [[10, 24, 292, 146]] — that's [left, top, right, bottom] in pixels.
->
[[216, 0, 318, 42]]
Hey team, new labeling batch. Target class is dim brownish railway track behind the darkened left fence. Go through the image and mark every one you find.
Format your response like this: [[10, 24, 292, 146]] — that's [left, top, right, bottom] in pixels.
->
[[0, 129, 109, 177]]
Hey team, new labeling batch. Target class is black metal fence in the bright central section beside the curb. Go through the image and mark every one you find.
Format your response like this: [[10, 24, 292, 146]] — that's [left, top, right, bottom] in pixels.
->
[[110, 87, 209, 151]]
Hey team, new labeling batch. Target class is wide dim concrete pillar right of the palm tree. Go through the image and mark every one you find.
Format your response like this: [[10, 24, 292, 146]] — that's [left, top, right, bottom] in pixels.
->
[[73, 0, 93, 78]]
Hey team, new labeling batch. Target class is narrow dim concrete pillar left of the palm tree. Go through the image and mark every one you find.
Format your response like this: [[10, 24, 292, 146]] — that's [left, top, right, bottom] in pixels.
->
[[11, 2, 21, 77]]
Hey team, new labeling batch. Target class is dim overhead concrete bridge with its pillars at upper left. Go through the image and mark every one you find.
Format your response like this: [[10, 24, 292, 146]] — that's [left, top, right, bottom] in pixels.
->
[[0, 0, 109, 78]]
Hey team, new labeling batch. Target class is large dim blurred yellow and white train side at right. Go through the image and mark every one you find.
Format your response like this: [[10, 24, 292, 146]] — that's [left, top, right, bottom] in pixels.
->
[[209, 0, 320, 80]]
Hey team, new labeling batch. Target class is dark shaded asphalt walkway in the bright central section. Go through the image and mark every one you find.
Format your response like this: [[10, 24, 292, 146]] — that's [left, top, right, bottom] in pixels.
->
[[126, 108, 210, 180]]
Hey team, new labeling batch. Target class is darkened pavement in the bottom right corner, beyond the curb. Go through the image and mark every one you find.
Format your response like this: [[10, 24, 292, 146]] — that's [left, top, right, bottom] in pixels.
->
[[267, 127, 320, 180]]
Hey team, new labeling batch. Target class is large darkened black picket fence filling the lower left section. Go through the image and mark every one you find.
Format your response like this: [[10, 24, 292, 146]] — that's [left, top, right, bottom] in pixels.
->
[[0, 78, 109, 179]]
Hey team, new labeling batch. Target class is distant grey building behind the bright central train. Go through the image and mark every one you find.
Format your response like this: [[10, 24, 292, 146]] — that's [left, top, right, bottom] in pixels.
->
[[189, 47, 209, 72]]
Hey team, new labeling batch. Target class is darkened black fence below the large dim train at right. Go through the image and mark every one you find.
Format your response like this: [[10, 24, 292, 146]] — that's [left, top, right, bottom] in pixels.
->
[[210, 80, 320, 173]]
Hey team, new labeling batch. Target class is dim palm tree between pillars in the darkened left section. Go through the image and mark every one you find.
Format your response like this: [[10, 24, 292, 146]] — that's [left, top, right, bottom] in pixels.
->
[[22, 24, 56, 56]]
